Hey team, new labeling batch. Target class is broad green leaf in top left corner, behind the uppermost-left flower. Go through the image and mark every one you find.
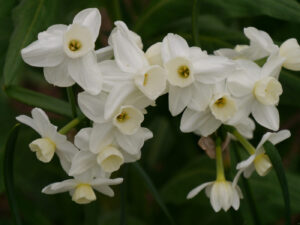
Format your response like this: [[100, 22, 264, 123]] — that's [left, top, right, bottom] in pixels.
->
[[3, 0, 56, 85]]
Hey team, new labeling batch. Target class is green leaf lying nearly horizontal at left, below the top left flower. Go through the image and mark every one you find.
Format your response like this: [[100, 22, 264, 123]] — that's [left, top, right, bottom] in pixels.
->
[[5, 86, 79, 117]]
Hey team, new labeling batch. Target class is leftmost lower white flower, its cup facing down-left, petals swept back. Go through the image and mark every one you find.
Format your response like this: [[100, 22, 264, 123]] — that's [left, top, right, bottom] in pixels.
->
[[16, 108, 78, 171]]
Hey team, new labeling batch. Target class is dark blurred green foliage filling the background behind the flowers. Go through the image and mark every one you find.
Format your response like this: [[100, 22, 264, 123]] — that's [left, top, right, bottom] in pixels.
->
[[0, 0, 300, 225]]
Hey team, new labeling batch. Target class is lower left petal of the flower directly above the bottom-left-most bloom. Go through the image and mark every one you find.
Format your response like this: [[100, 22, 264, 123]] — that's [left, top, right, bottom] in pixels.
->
[[69, 151, 97, 176]]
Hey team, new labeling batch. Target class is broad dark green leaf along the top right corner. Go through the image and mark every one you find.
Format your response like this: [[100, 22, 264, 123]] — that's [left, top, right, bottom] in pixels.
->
[[206, 0, 300, 23]]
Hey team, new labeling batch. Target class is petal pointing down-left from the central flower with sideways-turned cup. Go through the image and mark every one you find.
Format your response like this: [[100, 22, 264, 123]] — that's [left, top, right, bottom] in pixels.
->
[[104, 82, 135, 119]]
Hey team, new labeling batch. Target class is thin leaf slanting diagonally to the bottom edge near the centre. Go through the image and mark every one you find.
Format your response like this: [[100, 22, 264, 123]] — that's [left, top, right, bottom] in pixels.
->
[[133, 162, 175, 225]]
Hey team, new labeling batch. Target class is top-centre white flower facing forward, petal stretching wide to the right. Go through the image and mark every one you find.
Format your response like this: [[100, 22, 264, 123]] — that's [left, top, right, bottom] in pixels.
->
[[161, 34, 234, 116]]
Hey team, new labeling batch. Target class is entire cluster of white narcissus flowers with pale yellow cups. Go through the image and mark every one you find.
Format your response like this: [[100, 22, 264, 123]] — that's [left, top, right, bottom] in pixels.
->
[[17, 8, 292, 212]]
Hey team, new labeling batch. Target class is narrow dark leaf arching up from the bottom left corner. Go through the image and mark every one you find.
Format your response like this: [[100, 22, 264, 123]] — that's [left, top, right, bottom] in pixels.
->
[[3, 124, 22, 225]]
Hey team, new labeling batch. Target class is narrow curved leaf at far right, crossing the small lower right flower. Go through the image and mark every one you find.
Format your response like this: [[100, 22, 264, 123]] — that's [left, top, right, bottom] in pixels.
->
[[264, 141, 291, 225]]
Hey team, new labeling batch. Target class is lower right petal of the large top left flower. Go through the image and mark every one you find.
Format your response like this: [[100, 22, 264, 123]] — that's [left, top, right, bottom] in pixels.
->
[[68, 52, 103, 95]]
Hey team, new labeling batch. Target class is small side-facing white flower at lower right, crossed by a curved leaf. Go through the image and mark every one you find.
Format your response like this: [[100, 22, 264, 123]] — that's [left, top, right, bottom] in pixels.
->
[[235, 130, 291, 178]]
